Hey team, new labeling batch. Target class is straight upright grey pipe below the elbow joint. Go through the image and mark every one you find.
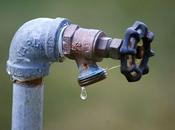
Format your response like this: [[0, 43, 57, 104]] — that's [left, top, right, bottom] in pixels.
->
[[12, 83, 44, 130]]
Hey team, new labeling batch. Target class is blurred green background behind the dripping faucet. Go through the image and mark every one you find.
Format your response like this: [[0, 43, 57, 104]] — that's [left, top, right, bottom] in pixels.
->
[[0, 0, 175, 130]]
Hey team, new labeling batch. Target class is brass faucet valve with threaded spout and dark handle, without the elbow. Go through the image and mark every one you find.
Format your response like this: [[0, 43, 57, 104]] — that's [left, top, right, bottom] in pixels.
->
[[63, 21, 154, 86]]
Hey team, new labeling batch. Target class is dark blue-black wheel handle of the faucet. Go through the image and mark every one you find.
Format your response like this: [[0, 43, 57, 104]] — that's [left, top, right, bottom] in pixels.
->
[[119, 21, 154, 82]]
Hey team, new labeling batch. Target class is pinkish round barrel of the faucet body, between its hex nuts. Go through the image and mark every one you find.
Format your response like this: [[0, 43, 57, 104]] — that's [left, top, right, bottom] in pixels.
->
[[71, 28, 105, 60]]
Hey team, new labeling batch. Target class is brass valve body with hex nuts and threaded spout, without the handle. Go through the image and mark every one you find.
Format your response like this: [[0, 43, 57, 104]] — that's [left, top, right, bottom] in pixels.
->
[[63, 25, 122, 86]]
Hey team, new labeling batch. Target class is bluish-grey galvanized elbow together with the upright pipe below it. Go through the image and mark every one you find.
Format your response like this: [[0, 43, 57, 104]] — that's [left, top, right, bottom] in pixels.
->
[[7, 18, 70, 130]]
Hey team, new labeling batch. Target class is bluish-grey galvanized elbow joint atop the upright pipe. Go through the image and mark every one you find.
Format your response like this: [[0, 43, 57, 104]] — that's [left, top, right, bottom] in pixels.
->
[[7, 18, 70, 81]]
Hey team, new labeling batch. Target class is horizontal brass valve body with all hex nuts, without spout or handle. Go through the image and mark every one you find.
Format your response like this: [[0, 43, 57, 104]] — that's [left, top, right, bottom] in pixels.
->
[[63, 24, 122, 62]]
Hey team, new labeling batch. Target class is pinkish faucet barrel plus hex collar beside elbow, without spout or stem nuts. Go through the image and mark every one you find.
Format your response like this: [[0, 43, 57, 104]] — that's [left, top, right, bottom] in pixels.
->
[[63, 24, 105, 60]]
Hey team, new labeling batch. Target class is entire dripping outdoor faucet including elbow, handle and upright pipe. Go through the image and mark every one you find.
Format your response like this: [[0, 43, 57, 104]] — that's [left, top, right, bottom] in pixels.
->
[[7, 18, 154, 130]]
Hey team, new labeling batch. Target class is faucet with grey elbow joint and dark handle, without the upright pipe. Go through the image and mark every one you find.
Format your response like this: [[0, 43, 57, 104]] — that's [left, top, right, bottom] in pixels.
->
[[7, 18, 154, 86]]
